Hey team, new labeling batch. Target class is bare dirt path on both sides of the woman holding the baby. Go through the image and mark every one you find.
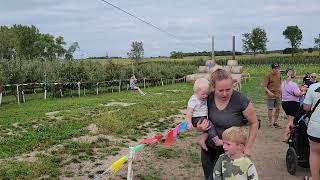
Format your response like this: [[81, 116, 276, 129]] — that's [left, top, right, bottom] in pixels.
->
[[110, 105, 310, 180]]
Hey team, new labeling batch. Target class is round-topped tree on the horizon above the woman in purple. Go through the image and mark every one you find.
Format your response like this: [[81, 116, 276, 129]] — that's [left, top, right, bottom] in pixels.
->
[[282, 26, 302, 56]]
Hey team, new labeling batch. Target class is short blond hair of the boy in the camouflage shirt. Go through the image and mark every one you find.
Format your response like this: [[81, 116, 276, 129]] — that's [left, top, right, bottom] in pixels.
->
[[222, 126, 247, 145]]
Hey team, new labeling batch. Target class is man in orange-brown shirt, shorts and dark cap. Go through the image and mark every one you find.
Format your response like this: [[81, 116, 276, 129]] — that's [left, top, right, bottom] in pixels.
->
[[261, 63, 281, 128]]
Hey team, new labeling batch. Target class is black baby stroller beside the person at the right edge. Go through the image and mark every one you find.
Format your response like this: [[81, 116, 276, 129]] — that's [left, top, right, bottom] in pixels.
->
[[286, 106, 310, 175]]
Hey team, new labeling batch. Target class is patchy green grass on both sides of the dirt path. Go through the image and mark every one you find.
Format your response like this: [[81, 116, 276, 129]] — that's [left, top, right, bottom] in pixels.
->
[[0, 65, 319, 179]]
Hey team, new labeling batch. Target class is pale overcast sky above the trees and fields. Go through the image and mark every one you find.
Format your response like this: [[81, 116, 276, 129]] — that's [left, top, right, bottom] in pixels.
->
[[0, 0, 320, 57]]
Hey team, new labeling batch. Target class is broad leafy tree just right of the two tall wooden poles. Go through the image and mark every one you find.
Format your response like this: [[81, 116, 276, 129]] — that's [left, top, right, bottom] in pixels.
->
[[242, 28, 268, 56]]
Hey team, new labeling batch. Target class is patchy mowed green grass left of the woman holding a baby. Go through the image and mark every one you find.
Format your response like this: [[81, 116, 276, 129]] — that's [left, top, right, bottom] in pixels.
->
[[0, 83, 192, 179]]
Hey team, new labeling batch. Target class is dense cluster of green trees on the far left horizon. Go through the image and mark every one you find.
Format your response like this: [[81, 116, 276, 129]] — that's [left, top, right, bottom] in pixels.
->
[[0, 24, 80, 60]]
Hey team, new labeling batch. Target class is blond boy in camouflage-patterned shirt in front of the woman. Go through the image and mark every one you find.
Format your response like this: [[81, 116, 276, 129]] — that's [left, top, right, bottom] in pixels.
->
[[213, 127, 259, 180]]
